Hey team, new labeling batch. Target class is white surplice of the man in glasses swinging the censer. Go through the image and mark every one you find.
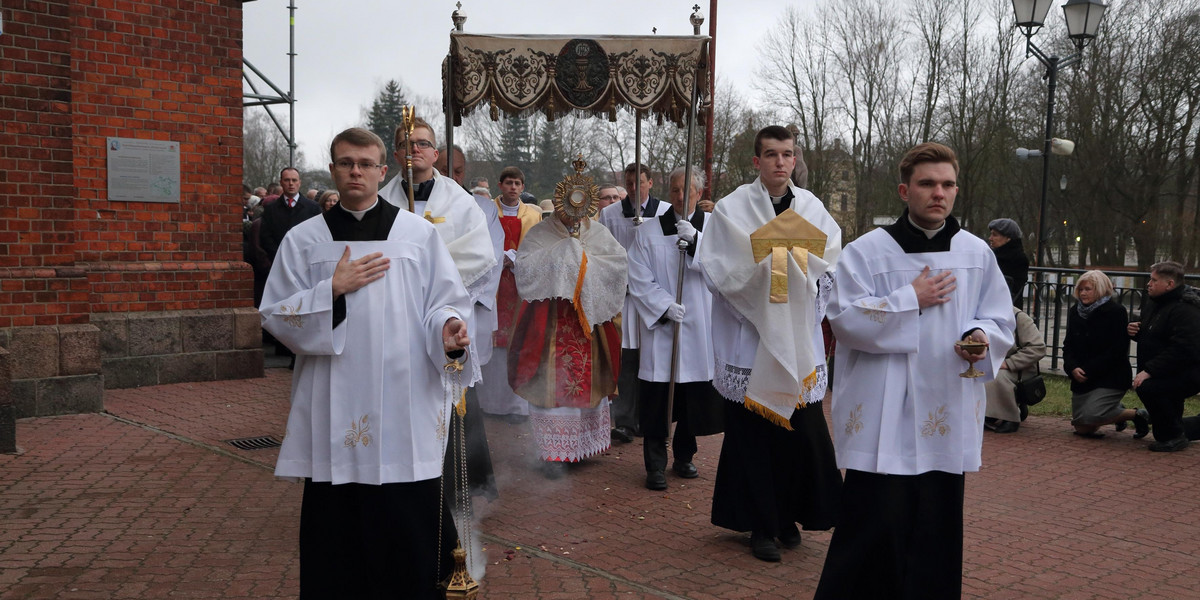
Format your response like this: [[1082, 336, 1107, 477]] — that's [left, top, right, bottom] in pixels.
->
[[259, 208, 474, 484]]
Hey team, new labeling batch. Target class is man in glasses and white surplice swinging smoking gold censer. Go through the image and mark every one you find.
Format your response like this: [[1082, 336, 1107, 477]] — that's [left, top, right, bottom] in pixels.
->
[[260, 127, 475, 599]]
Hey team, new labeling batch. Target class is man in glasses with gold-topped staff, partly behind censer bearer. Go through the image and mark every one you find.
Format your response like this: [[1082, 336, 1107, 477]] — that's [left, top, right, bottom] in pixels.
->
[[379, 114, 499, 499]]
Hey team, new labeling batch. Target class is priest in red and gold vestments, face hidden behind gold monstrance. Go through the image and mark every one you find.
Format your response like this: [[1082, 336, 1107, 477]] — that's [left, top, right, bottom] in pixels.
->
[[508, 157, 626, 479]]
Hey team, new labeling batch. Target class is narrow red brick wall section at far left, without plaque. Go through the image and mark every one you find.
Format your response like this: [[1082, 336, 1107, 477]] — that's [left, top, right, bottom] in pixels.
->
[[0, 0, 88, 328]]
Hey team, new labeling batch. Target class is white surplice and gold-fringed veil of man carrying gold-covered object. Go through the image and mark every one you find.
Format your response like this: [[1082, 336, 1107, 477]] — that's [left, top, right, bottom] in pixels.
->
[[696, 179, 841, 422]]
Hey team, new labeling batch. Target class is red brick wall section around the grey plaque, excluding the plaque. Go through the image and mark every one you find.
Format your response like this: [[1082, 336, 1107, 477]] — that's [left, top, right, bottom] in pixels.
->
[[71, 0, 253, 312]]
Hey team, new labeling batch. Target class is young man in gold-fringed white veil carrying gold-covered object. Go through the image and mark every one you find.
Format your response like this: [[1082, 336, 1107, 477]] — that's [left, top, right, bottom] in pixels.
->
[[696, 126, 841, 562]]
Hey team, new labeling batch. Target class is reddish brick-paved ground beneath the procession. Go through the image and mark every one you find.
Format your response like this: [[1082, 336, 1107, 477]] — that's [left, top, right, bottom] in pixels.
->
[[0, 368, 1200, 600]]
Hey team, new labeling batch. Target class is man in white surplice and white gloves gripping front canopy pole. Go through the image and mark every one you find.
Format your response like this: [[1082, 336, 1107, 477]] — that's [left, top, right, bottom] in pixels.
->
[[628, 168, 725, 491]]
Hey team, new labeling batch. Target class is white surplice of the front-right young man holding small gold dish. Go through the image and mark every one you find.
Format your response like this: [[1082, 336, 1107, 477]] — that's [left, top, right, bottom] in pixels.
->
[[828, 228, 1015, 475]]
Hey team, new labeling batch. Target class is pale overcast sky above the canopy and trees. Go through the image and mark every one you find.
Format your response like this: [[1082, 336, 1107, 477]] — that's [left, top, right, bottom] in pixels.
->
[[242, 0, 816, 167]]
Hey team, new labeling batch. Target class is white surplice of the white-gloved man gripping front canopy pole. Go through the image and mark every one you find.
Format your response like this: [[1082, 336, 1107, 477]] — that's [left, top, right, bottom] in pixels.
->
[[625, 211, 713, 383]]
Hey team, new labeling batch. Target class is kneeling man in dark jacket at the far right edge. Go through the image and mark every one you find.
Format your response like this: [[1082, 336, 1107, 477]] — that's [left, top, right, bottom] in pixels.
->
[[1128, 260, 1200, 452]]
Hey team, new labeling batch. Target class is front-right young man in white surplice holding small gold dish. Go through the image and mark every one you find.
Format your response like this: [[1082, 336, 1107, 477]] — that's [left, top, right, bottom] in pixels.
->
[[816, 143, 1015, 599]]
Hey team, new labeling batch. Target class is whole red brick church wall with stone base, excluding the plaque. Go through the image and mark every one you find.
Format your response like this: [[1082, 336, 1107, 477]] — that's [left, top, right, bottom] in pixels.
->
[[0, 0, 262, 441]]
